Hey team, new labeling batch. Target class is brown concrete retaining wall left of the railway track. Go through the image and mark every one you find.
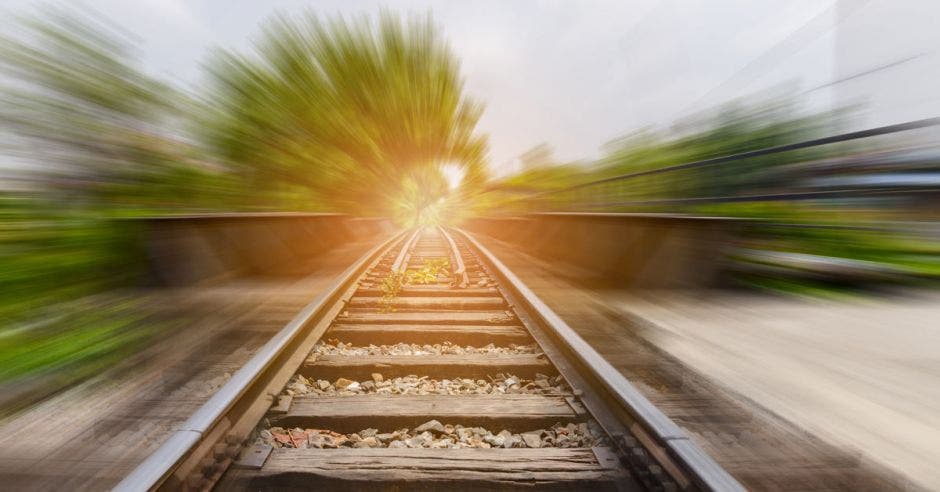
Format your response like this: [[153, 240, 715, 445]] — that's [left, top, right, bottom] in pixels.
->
[[140, 213, 394, 286]]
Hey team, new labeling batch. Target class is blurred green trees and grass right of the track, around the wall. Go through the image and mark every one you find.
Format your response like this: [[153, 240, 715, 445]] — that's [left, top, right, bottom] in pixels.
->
[[481, 90, 940, 295]]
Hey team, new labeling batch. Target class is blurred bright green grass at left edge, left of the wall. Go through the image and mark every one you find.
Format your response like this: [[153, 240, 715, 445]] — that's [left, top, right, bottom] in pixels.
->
[[0, 196, 152, 413]]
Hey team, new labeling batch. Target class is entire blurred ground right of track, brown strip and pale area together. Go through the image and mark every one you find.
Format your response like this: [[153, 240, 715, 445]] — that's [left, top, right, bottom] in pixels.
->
[[479, 237, 928, 490]]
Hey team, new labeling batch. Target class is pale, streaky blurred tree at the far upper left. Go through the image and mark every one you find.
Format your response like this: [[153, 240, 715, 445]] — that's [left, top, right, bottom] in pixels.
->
[[0, 9, 217, 212]]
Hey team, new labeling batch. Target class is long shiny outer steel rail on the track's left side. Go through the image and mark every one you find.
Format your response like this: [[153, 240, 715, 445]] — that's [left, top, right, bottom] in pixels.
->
[[113, 233, 407, 492]]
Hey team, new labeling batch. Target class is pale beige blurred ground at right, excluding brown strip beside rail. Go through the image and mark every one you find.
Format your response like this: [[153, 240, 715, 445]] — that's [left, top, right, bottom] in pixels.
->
[[602, 292, 940, 490]]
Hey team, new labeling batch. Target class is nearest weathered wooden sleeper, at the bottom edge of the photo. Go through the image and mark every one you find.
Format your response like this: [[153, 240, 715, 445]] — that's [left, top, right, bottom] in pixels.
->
[[230, 448, 624, 491]]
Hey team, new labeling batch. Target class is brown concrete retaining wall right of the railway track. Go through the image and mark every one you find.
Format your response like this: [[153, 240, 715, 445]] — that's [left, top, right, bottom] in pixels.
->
[[464, 213, 740, 288]]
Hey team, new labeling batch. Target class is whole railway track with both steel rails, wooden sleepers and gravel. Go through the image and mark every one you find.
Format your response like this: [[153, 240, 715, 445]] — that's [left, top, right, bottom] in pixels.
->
[[118, 227, 741, 490]]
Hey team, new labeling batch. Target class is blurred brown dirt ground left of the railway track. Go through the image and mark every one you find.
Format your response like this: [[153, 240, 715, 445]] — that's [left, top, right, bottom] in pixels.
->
[[0, 238, 386, 490]]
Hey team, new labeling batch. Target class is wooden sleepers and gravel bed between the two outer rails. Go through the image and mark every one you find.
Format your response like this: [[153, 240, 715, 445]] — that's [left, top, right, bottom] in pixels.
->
[[220, 229, 629, 490]]
